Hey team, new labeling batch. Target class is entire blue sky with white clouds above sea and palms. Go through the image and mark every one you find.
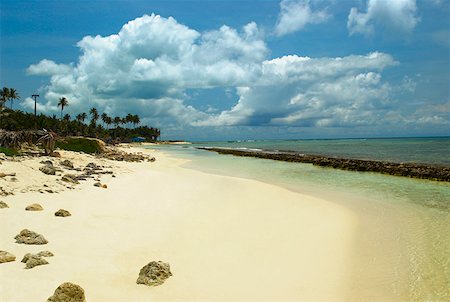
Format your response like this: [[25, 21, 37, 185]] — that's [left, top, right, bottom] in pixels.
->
[[0, 0, 450, 141]]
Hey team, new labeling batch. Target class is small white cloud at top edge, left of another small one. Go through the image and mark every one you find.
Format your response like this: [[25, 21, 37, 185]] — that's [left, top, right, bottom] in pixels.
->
[[275, 0, 329, 36]]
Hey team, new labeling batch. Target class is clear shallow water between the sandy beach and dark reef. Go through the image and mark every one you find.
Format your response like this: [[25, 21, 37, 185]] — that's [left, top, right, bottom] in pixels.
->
[[146, 146, 450, 301]]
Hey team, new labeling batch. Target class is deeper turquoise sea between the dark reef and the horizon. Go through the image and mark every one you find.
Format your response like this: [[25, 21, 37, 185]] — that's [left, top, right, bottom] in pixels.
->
[[193, 137, 450, 165]]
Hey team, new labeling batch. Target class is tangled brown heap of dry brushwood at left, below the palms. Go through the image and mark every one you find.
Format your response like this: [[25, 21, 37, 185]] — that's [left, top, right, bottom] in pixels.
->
[[0, 129, 56, 154]]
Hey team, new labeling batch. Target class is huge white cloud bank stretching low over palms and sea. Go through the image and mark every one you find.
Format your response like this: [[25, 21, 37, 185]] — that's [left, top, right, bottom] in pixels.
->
[[23, 12, 442, 138]]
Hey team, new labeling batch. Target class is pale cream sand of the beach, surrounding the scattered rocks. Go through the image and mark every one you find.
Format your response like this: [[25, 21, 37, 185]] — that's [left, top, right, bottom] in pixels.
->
[[0, 147, 357, 302]]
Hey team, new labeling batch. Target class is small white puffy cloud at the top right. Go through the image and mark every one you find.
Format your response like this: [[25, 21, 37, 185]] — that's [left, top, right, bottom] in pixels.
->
[[347, 0, 419, 35]]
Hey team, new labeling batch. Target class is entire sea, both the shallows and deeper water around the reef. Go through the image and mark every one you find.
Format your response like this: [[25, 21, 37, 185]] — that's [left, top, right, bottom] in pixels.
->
[[146, 137, 450, 301]]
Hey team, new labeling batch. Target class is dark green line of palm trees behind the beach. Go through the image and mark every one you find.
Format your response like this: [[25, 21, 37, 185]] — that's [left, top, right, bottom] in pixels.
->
[[0, 87, 160, 142]]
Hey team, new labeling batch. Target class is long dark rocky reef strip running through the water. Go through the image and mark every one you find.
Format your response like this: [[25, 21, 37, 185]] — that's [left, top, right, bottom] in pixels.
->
[[198, 148, 450, 182]]
